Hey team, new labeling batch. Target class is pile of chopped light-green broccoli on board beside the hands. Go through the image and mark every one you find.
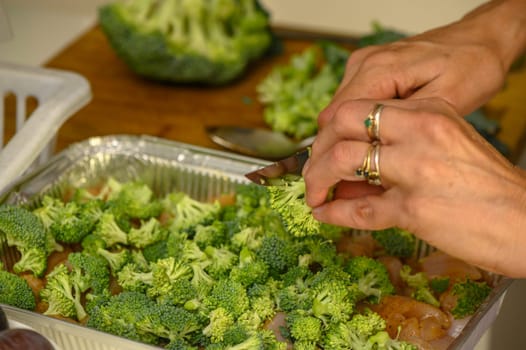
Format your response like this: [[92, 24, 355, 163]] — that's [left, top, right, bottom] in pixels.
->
[[256, 42, 349, 140]]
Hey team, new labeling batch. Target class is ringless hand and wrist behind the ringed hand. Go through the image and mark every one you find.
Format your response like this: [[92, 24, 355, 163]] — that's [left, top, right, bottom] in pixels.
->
[[319, 0, 526, 127]]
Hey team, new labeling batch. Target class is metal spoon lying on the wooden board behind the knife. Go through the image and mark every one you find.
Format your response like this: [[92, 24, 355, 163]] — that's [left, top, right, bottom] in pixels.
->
[[206, 126, 314, 160]]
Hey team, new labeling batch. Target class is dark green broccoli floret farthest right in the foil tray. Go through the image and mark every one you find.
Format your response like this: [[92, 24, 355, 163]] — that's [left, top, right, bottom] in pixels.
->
[[451, 279, 491, 319]]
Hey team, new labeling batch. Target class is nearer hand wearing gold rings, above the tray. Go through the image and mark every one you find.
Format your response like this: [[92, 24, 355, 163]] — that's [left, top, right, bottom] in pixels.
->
[[304, 99, 526, 277]]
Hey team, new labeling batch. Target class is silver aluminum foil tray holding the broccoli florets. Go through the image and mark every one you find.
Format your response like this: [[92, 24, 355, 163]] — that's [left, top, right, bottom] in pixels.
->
[[0, 135, 511, 350]]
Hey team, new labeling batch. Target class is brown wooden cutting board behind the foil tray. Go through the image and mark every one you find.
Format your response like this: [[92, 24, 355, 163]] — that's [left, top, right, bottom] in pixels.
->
[[40, 27, 526, 161]]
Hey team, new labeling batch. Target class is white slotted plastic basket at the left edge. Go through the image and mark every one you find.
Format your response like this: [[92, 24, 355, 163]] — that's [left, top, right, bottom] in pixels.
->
[[0, 62, 91, 190]]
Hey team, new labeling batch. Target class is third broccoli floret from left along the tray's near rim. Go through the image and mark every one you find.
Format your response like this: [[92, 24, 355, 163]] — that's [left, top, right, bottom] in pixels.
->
[[86, 291, 159, 344]]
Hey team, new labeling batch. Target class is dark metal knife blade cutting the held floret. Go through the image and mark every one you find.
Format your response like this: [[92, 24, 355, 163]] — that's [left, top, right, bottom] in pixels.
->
[[245, 148, 310, 186]]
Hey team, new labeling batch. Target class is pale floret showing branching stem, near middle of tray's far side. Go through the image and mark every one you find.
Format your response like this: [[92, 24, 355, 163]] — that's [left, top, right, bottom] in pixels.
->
[[162, 192, 221, 231]]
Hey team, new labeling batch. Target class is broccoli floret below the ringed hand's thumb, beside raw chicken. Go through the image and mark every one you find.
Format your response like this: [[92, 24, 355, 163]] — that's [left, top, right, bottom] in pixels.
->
[[346, 256, 395, 303]]
